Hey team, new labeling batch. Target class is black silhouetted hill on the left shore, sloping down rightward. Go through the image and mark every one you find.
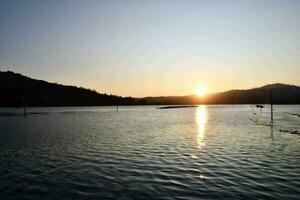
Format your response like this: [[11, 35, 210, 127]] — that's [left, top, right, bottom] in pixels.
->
[[0, 71, 134, 106]]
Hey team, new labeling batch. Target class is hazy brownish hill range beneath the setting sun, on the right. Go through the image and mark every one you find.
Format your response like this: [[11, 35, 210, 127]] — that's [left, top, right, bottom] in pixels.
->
[[139, 83, 300, 104]]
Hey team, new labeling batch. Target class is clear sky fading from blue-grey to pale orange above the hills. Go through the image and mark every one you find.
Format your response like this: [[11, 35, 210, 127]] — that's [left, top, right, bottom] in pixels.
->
[[0, 0, 300, 97]]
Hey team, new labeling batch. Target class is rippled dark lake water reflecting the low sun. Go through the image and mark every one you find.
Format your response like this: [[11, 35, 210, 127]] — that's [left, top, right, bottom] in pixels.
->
[[0, 105, 300, 200]]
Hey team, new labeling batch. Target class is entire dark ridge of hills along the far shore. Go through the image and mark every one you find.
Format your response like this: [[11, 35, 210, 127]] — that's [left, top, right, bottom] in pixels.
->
[[0, 71, 300, 107]]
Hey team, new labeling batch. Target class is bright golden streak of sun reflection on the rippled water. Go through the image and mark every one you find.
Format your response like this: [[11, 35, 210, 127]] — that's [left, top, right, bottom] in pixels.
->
[[196, 105, 207, 148]]
